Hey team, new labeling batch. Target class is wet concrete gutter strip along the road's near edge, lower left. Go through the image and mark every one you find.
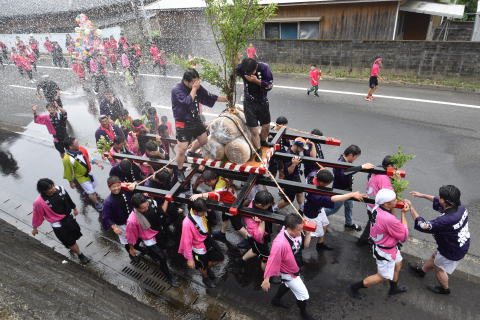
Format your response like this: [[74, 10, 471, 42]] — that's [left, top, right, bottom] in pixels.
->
[[0, 192, 249, 320]]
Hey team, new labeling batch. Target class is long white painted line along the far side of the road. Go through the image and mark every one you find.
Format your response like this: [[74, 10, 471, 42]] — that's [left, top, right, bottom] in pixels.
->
[[4, 66, 480, 110]]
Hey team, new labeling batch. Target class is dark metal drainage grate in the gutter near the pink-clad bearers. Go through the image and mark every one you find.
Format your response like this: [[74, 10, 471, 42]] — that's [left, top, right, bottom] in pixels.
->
[[122, 261, 170, 296]]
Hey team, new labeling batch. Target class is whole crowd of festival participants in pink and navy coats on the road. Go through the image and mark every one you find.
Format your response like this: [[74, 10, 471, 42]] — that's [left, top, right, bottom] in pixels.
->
[[0, 30, 470, 319]]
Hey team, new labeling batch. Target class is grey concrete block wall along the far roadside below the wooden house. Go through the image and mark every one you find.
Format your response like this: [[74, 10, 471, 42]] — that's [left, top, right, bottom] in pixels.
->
[[254, 40, 480, 80]]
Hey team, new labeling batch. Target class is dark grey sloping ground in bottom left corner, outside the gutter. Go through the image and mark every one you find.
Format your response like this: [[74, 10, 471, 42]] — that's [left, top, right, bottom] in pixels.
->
[[0, 219, 166, 320]]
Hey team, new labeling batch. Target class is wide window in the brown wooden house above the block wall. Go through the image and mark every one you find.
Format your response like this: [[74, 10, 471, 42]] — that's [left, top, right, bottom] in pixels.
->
[[265, 21, 320, 39]]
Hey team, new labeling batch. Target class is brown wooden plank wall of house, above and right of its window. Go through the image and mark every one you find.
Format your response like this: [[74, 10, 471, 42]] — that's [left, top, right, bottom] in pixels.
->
[[275, 1, 398, 40]]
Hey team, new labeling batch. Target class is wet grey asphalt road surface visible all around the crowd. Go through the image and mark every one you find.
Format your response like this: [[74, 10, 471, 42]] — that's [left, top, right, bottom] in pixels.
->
[[0, 58, 480, 319]]
